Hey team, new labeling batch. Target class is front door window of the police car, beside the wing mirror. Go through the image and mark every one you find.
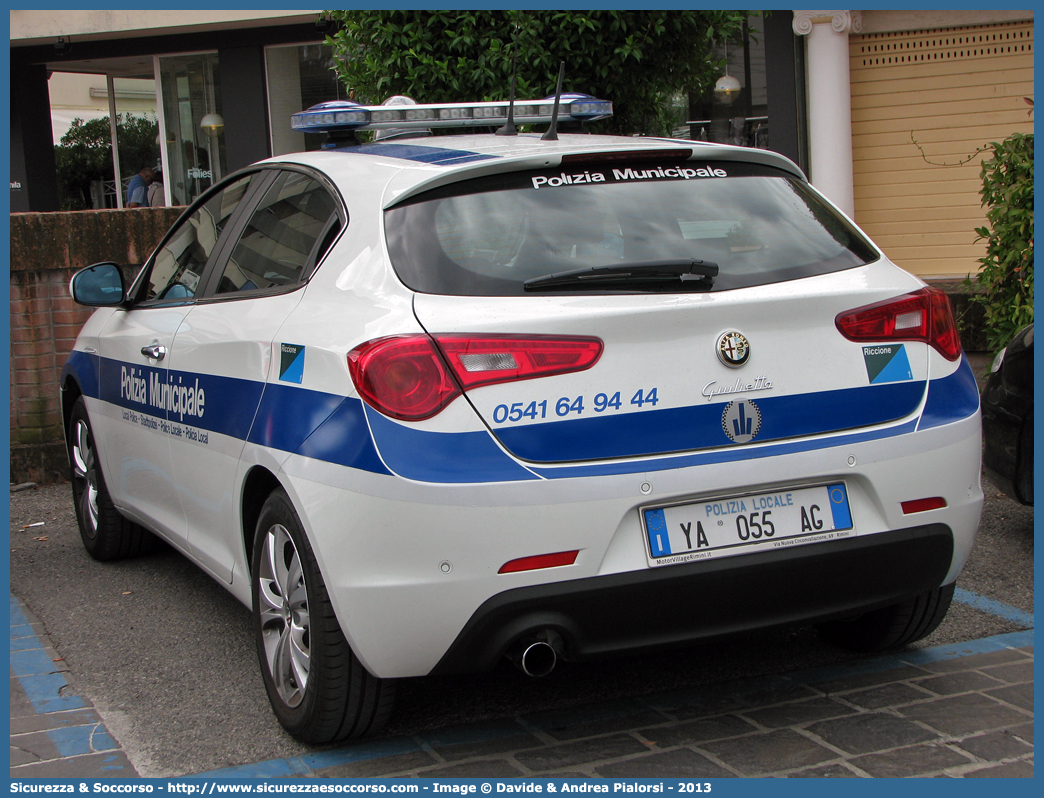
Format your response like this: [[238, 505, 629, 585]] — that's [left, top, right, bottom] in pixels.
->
[[144, 172, 261, 302]]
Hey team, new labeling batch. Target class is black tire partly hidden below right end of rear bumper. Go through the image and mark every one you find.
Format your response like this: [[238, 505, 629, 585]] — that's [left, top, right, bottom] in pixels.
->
[[820, 584, 954, 652]]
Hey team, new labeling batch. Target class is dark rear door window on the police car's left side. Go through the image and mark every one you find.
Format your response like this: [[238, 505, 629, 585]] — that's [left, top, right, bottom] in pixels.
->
[[217, 171, 340, 295]]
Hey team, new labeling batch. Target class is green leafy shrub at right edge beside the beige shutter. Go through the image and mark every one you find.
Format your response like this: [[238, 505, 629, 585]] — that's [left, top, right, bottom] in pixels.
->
[[966, 133, 1034, 350]]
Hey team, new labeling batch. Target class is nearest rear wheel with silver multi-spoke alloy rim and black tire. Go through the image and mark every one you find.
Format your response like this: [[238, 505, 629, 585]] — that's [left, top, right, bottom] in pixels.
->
[[251, 489, 395, 744]]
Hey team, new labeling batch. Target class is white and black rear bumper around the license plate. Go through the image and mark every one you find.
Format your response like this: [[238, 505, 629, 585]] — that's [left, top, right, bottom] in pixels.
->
[[285, 399, 982, 678]]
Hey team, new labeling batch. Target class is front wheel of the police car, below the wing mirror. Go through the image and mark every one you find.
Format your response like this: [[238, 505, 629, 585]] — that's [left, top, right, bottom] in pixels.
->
[[68, 397, 156, 561]]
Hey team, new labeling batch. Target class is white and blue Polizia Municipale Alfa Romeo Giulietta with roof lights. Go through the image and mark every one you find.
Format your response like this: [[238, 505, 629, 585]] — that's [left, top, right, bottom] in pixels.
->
[[62, 95, 982, 742]]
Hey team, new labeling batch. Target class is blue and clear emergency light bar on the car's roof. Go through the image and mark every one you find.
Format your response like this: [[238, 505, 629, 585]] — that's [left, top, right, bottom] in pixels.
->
[[290, 94, 613, 133]]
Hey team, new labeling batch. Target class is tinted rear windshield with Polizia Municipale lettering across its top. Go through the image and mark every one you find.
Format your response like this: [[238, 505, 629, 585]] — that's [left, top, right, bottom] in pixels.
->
[[385, 161, 879, 297]]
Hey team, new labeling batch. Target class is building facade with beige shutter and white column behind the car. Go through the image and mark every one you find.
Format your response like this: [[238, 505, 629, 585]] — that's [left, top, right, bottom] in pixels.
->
[[10, 10, 1034, 279]]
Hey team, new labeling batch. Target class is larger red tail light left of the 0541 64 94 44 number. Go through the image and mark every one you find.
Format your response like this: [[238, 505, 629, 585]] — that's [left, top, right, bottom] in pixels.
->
[[348, 333, 602, 421]]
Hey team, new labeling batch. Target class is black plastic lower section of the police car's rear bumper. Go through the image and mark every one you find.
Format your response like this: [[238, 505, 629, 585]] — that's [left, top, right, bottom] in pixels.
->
[[432, 523, 953, 674]]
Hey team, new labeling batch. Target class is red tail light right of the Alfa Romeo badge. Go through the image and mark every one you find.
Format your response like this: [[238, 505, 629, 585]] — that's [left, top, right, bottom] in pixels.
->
[[834, 288, 962, 360]]
